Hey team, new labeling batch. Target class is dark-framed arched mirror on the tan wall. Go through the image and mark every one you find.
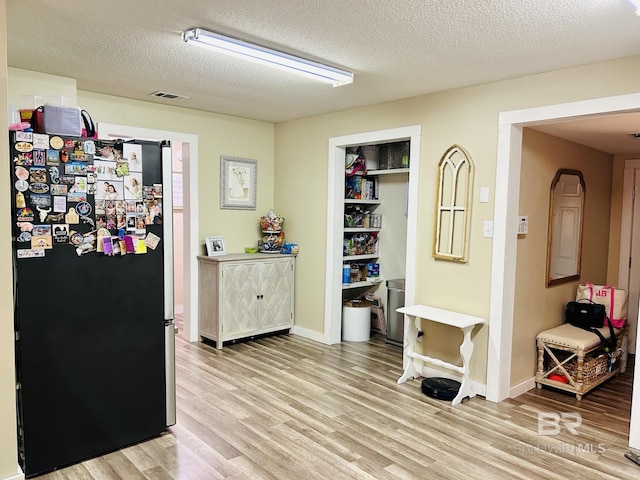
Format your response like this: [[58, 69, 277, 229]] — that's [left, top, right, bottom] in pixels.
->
[[547, 169, 585, 287]]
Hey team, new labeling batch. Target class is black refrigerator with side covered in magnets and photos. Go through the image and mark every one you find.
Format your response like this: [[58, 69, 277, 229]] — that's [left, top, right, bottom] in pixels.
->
[[9, 131, 175, 477]]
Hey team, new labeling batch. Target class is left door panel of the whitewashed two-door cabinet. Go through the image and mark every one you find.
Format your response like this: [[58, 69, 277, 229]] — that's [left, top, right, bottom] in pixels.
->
[[222, 263, 260, 338]]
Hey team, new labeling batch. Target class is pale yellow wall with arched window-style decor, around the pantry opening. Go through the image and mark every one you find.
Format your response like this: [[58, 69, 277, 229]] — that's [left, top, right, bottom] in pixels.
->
[[275, 57, 640, 383]]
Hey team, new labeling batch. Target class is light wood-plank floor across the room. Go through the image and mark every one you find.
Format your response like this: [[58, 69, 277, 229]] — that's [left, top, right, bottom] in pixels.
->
[[33, 335, 640, 480]]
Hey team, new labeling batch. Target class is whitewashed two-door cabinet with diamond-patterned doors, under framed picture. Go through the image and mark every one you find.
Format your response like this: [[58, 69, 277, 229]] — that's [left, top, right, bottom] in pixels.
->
[[198, 253, 295, 349]]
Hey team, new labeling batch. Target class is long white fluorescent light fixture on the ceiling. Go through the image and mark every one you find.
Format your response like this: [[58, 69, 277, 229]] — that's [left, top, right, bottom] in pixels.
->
[[182, 28, 353, 87]]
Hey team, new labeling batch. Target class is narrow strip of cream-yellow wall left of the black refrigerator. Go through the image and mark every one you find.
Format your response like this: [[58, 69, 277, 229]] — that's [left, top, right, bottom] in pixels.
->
[[0, 0, 18, 478]]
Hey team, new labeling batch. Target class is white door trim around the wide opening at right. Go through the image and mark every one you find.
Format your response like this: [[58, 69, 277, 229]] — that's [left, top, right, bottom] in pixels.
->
[[487, 94, 640, 448]]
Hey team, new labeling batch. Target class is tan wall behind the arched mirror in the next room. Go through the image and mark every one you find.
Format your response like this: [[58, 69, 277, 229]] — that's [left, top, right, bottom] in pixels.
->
[[511, 128, 613, 385]]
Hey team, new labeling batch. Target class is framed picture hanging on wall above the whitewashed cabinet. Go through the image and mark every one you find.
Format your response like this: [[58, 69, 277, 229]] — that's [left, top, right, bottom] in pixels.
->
[[220, 155, 258, 210]]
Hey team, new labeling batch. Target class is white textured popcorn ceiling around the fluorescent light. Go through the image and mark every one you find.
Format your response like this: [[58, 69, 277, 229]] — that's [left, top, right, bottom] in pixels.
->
[[7, 0, 640, 151]]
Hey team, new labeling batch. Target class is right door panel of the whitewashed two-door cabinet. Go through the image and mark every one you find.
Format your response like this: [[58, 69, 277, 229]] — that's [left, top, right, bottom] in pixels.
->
[[260, 260, 292, 327]]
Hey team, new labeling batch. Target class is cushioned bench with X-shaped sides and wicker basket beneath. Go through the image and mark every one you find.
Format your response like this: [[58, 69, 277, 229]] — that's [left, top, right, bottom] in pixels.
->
[[536, 323, 626, 400]]
